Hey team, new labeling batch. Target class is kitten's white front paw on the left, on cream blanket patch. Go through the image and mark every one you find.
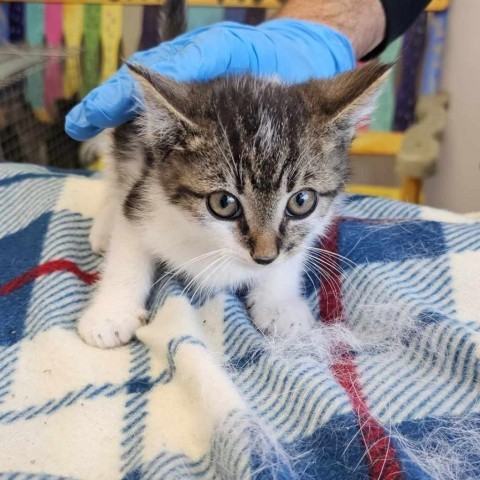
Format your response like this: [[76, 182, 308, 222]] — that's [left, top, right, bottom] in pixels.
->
[[78, 302, 147, 348]]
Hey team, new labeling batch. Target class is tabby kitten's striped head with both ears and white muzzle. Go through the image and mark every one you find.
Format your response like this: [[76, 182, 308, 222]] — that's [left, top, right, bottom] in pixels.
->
[[122, 63, 389, 276]]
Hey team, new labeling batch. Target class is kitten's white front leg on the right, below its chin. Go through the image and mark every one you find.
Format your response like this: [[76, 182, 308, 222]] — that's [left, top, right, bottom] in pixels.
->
[[247, 259, 315, 336]]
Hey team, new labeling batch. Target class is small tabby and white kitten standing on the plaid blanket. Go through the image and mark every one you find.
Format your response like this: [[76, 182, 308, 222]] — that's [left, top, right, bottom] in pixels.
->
[[79, 59, 389, 348]]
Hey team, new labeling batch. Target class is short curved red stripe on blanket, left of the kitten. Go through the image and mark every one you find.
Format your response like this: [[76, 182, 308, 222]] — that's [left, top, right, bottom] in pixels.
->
[[0, 259, 98, 295]]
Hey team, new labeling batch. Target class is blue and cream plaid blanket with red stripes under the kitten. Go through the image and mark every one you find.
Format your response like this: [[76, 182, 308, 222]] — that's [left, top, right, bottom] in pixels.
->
[[0, 164, 480, 480]]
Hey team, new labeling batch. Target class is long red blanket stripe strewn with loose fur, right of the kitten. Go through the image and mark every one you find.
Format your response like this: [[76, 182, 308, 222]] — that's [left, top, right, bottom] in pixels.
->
[[319, 222, 402, 480]]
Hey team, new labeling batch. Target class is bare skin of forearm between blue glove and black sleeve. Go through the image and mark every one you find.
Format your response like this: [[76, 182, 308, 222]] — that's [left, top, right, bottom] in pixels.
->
[[278, 0, 386, 58]]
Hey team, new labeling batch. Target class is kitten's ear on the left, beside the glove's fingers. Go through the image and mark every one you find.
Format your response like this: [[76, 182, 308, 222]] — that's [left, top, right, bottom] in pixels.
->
[[126, 63, 197, 141]]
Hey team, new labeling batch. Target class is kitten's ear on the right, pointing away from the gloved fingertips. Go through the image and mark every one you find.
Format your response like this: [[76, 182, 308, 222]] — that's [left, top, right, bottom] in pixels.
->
[[301, 62, 393, 126]]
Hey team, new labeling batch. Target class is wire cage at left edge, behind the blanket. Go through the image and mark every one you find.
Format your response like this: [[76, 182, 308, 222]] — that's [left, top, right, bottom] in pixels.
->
[[0, 44, 81, 168]]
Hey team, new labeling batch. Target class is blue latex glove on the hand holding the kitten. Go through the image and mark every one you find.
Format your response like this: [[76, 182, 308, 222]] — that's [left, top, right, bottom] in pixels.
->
[[65, 19, 355, 140]]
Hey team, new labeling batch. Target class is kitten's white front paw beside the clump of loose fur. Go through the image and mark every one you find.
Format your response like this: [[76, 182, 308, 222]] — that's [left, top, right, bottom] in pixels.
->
[[247, 297, 315, 337]]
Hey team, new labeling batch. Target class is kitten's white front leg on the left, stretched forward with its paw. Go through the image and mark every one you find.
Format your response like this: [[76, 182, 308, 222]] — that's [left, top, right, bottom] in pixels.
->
[[78, 214, 153, 348]]
